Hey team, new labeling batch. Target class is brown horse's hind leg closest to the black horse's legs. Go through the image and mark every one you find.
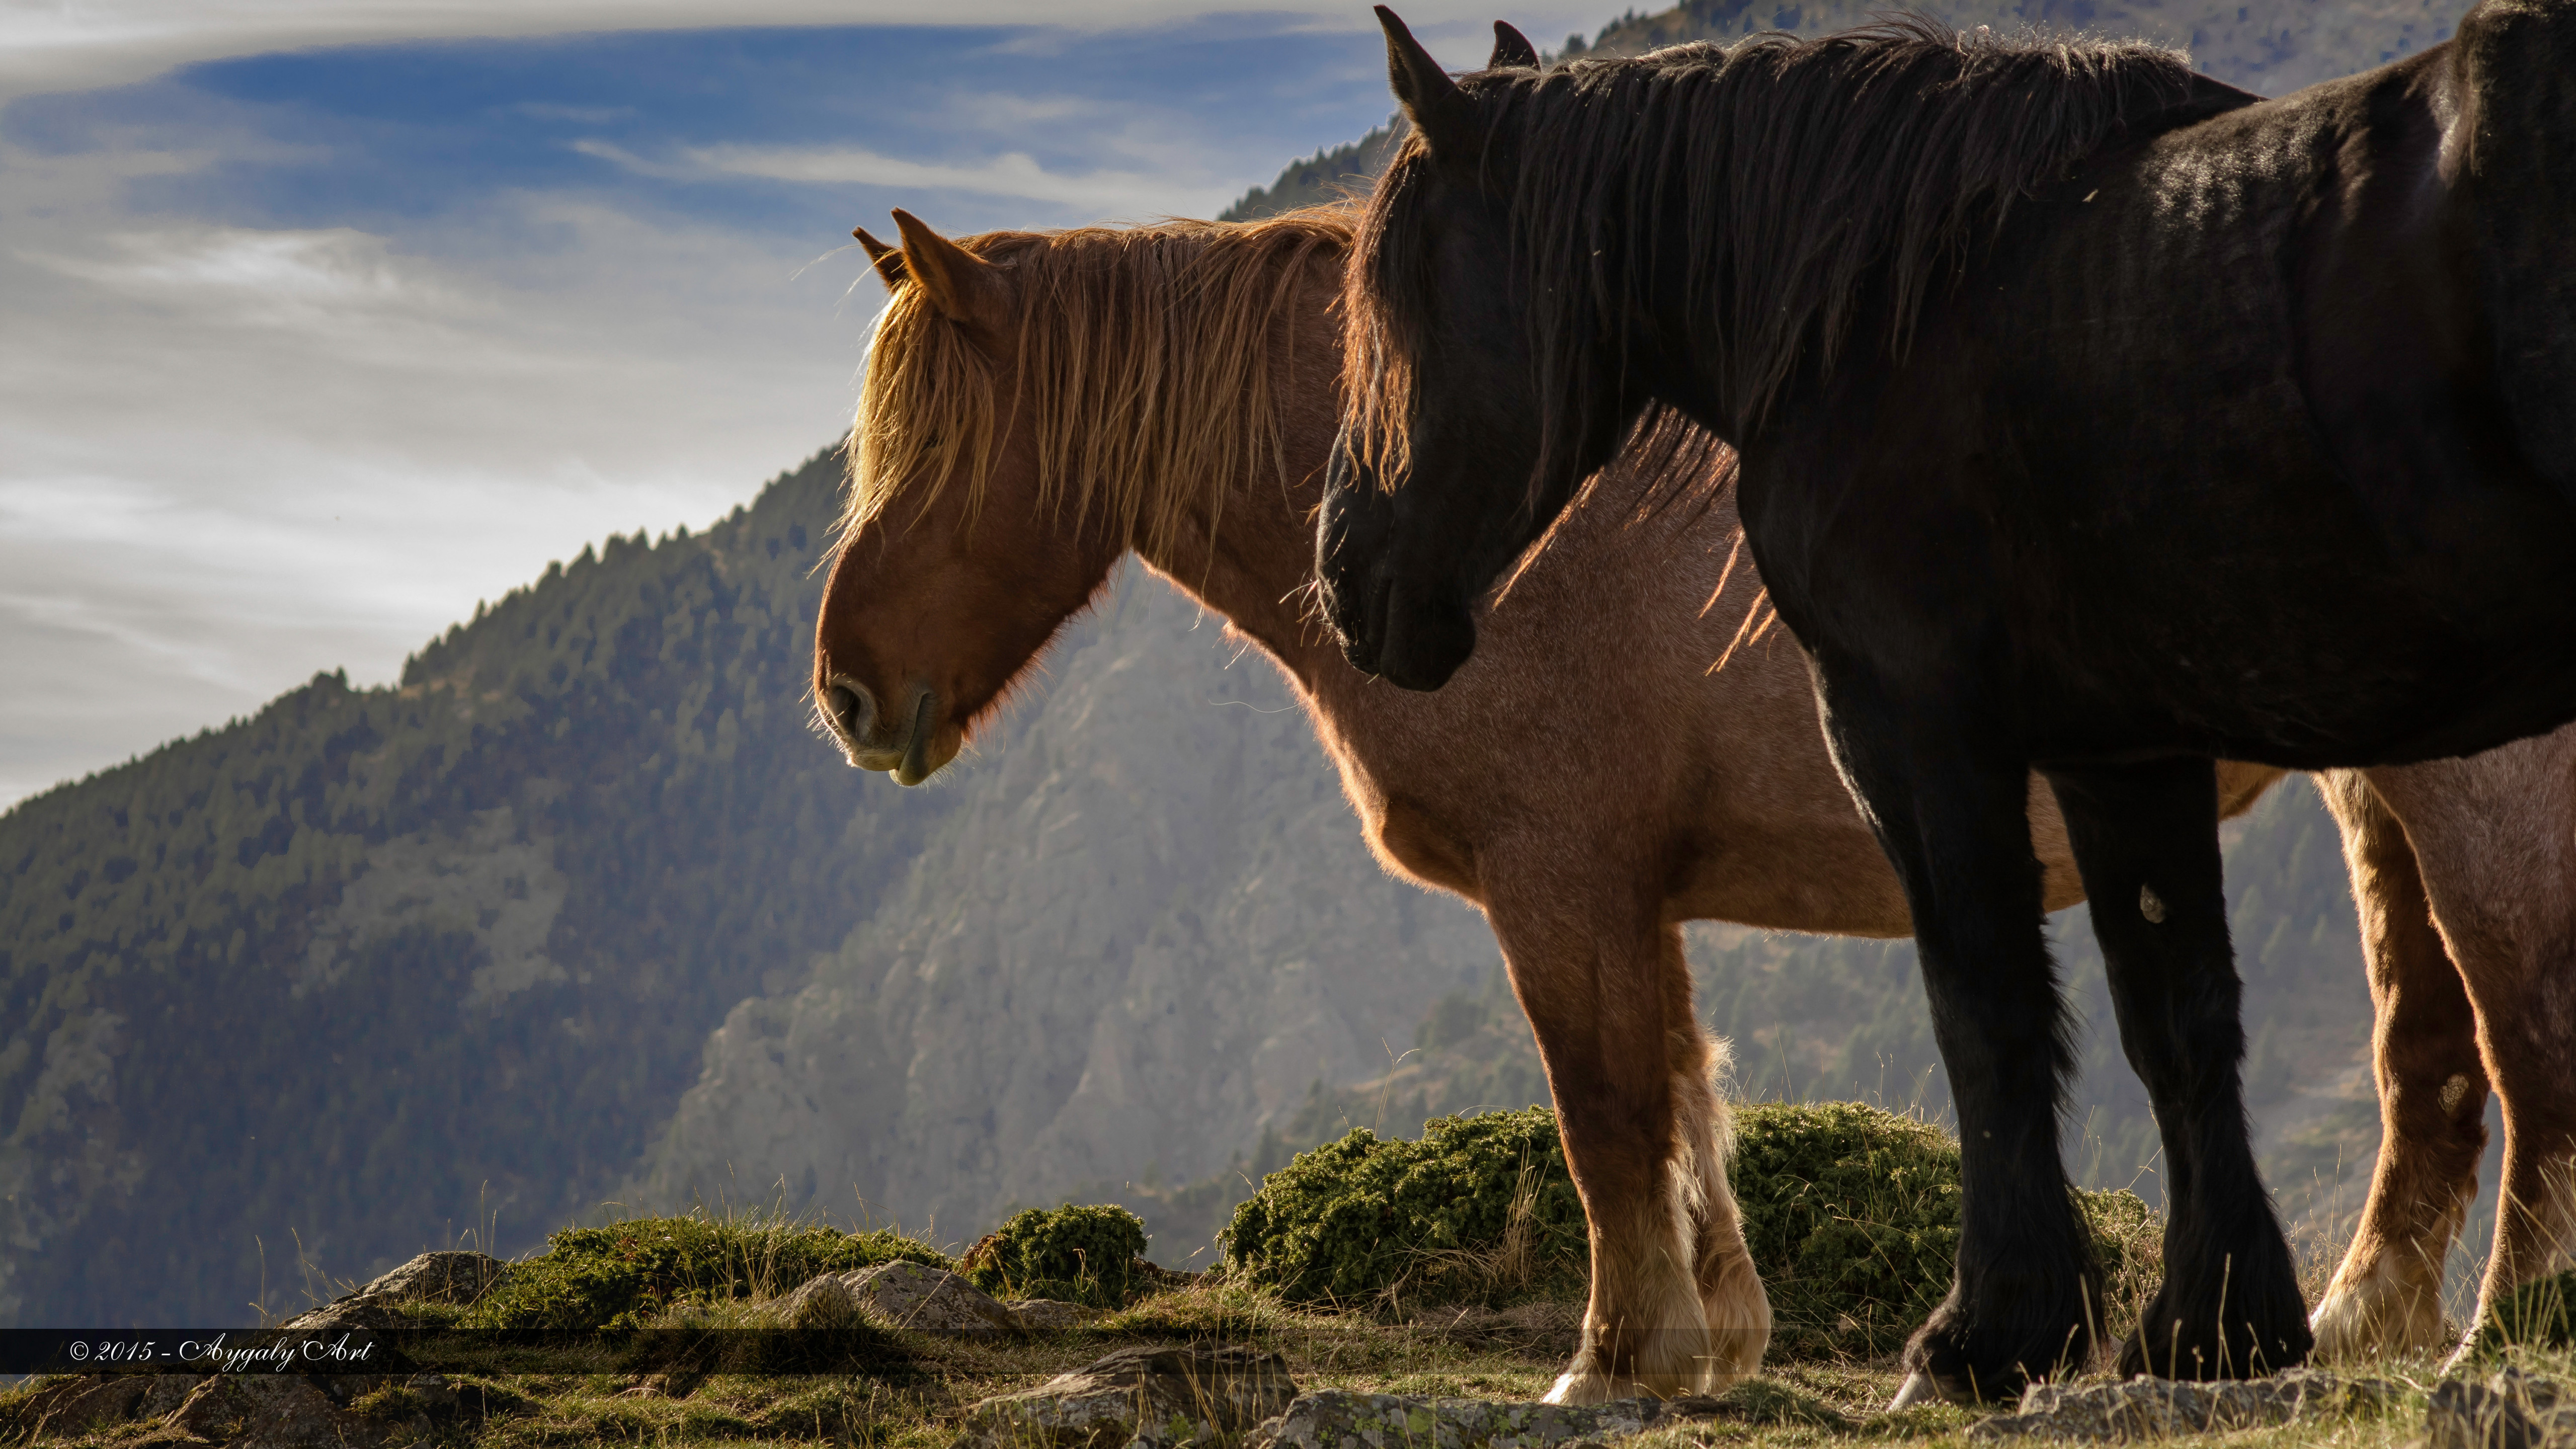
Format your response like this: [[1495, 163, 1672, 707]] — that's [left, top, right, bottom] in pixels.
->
[[2308, 771, 2486, 1359]]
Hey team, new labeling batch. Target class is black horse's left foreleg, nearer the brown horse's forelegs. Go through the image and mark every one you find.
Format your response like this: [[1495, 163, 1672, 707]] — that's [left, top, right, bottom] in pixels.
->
[[1819, 658, 2102, 1403]]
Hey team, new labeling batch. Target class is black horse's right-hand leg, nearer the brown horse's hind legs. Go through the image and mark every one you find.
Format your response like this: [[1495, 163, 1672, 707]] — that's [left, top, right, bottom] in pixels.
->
[[2048, 761, 2313, 1380]]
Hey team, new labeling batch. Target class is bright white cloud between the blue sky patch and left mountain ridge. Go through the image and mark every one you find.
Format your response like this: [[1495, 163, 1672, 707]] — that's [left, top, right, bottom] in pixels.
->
[[0, 174, 876, 804]]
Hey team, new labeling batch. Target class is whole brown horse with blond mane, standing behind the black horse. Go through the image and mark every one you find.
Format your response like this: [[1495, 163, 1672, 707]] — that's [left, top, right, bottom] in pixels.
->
[[814, 211, 2576, 1403]]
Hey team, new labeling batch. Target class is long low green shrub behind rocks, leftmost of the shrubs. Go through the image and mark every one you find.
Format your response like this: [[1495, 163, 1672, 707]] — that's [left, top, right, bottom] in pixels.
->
[[461, 1217, 950, 1330]]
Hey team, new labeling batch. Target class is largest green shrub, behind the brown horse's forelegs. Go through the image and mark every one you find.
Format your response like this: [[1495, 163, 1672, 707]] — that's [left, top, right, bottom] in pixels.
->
[[1224, 1101, 2153, 1353]]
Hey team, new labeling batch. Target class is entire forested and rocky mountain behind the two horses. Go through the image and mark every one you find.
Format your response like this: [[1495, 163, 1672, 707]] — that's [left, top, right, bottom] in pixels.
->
[[0, 0, 2493, 1323]]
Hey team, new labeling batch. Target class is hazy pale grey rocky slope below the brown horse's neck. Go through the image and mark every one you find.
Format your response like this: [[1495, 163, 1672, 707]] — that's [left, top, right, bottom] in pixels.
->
[[636, 567, 1494, 1256]]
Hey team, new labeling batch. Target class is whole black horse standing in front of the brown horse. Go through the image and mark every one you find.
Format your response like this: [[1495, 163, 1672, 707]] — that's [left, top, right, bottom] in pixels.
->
[[1319, 0, 2576, 1400]]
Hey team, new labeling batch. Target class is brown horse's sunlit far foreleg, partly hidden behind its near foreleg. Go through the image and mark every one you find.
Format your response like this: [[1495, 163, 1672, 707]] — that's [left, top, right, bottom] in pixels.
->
[[1664, 931, 1769, 1392]]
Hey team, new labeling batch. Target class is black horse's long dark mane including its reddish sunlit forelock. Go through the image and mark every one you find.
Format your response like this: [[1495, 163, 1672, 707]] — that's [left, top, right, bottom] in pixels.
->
[[1345, 18, 2192, 474]]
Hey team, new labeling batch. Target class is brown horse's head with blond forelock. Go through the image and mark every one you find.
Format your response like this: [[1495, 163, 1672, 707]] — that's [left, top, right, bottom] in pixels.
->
[[814, 211, 1123, 784]]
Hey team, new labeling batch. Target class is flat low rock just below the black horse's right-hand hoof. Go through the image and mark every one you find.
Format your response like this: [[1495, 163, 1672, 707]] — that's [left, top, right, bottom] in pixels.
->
[[1968, 1369, 2393, 1444]]
